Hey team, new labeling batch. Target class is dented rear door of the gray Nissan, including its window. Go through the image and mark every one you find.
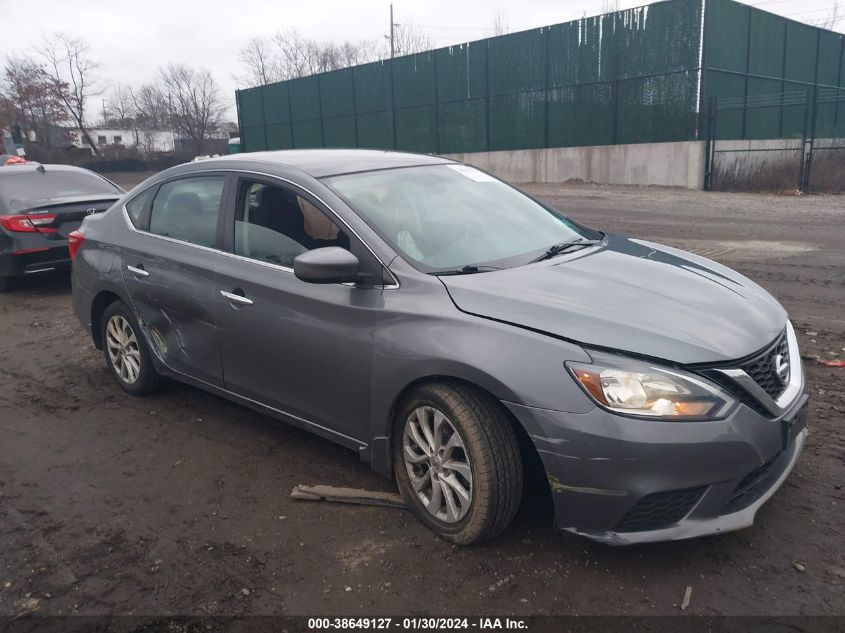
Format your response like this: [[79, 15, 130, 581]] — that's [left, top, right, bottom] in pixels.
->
[[121, 173, 226, 387]]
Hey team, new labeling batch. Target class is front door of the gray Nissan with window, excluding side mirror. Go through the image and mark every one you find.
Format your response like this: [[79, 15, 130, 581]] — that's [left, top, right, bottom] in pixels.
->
[[215, 179, 383, 446]]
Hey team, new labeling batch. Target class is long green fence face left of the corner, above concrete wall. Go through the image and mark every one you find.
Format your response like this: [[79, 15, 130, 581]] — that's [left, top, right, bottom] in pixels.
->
[[237, 0, 701, 153]]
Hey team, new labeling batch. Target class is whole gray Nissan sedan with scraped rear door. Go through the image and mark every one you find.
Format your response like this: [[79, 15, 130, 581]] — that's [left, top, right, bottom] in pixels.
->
[[70, 150, 807, 544]]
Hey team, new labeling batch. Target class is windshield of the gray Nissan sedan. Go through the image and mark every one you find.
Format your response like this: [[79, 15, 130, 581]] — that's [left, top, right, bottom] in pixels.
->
[[323, 164, 582, 272]]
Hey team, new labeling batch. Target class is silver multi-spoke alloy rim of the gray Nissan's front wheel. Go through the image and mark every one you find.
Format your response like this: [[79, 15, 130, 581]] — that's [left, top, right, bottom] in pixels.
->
[[402, 406, 473, 523]]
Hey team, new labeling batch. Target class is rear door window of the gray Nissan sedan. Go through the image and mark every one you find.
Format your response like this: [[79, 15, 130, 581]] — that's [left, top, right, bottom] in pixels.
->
[[149, 176, 225, 247]]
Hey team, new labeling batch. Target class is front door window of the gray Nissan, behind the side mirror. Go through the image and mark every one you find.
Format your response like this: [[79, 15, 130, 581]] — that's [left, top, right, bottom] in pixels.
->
[[235, 180, 349, 268]]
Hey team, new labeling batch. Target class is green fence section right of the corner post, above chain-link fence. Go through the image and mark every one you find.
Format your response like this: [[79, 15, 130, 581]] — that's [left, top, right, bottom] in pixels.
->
[[702, 0, 845, 140]]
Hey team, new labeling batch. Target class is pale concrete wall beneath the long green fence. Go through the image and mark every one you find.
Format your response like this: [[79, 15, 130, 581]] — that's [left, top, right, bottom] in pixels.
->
[[447, 141, 704, 189]]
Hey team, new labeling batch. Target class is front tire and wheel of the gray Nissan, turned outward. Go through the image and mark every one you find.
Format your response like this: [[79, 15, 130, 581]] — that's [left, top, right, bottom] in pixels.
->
[[393, 382, 523, 545]]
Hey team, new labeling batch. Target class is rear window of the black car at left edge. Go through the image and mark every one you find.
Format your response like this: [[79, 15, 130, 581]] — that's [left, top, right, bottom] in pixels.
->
[[0, 167, 122, 210]]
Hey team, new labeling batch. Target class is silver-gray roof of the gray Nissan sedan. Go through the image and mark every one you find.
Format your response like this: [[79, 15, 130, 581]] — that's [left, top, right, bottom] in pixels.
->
[[193, 149, 455, 178]]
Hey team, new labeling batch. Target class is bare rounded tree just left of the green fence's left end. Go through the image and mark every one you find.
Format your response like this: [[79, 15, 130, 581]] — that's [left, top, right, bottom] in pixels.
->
[[158, 64, 225, 154]]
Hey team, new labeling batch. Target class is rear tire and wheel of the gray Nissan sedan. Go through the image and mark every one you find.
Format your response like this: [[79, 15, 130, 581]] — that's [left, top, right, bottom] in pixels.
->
[[100, 301, 161, 396]]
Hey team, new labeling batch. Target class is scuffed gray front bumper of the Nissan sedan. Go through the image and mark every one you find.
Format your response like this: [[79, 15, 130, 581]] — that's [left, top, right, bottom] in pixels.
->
[[505, 391, 808, 545]]
